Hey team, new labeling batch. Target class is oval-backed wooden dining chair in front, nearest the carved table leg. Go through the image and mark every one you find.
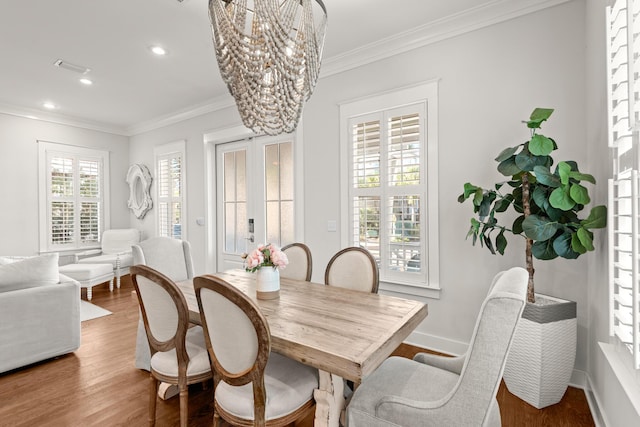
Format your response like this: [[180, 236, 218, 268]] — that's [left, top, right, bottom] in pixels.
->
[[194, 275, 318, 426]]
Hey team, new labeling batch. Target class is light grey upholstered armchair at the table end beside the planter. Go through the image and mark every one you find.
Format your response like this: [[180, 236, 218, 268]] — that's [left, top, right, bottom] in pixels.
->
[[346, 267, 529, 427]]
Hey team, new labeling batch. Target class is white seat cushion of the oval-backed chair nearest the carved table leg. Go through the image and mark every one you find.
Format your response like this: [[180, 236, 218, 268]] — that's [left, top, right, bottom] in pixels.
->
[[214, 352, 318, 420]]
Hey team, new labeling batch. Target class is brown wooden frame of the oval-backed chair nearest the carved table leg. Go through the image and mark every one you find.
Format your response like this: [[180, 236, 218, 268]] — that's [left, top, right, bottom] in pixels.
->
[[193, 275, 313, 427]]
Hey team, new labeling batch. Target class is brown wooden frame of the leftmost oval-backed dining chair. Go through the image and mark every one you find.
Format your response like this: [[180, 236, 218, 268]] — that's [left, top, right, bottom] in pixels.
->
[[131, 265, 212, 427]]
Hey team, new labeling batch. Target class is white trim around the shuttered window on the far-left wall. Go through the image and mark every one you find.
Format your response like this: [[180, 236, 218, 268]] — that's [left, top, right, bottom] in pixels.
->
[[37, 140, 111, 254]]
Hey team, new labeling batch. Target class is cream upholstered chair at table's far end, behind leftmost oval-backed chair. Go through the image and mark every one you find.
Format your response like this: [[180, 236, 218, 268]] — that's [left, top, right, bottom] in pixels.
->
[[132, 237, 193, 371]]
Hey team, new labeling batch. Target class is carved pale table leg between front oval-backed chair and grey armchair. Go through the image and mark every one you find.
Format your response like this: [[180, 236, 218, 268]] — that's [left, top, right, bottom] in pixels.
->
[[313, 370, 344, 427]]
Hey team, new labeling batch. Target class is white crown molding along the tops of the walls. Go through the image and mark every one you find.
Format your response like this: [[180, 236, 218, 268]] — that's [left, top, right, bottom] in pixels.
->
[[0, 0, 573, 136]]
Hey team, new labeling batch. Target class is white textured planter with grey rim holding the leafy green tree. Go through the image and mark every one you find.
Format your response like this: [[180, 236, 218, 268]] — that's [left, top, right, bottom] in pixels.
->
[[503, 294, 577, 409]]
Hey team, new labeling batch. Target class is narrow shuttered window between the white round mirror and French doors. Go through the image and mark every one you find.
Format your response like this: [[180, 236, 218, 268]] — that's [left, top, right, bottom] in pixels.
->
[[155, 141, 186, 239]]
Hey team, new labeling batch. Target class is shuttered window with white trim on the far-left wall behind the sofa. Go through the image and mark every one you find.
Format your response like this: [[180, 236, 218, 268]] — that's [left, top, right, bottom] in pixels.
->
[[38, 141, 109, 252]]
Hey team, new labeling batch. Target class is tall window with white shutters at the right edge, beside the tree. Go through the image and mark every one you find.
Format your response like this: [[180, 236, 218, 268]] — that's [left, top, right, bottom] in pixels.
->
[[607, 0, 640, 369]]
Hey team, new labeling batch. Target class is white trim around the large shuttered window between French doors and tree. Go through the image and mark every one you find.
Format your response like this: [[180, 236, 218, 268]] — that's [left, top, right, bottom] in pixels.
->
[[340, 79, 440, 298]]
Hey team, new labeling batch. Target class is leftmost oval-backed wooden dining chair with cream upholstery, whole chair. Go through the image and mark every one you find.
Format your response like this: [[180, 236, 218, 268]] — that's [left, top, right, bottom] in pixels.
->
[[130, 265, 212, 427]]
